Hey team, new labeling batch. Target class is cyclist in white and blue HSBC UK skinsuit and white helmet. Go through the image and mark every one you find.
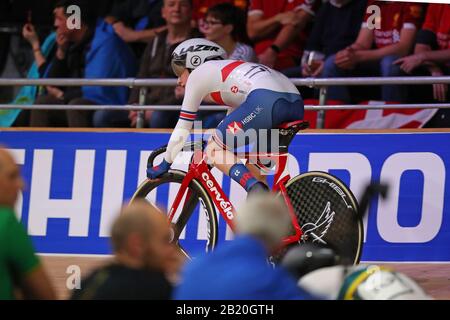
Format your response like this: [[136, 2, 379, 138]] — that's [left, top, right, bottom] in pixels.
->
[[147, 38, 304, 192]]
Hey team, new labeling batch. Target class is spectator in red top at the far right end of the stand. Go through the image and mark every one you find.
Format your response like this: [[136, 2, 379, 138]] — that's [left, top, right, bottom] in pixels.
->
[[395, 4, 450, 127]]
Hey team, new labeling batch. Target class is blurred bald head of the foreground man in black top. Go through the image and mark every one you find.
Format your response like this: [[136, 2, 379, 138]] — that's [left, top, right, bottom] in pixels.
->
[[111, 200, 174, 271]]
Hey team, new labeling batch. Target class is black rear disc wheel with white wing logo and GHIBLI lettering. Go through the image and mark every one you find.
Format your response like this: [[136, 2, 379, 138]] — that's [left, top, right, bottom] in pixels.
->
[[286, 172, 364, 264]]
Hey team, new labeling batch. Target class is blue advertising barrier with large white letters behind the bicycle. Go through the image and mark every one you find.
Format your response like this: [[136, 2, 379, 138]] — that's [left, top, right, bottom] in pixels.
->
[[0, 131, 450, 261]]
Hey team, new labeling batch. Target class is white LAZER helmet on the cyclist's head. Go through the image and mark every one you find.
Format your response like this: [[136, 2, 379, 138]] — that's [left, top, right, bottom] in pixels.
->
[[171, 38, 227, 77]]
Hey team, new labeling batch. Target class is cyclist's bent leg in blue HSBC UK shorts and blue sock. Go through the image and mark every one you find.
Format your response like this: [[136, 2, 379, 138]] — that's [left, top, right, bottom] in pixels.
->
[[207, 89, 303, 191]]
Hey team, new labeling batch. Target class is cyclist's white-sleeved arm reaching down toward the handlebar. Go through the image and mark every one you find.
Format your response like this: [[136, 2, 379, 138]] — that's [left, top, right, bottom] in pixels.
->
[[164, 66, 212, 163]]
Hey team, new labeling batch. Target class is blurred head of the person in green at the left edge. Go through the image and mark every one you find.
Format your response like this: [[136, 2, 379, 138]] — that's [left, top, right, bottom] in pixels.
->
[[0, 147, 24, 209]]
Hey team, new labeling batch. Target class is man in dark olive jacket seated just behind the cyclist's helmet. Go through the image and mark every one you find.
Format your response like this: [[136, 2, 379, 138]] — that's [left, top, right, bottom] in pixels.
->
[[125, 0, 201, 128]]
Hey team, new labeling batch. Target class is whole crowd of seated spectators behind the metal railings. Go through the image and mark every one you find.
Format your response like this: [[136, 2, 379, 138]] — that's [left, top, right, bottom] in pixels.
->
[[0, 0, 450, 128]]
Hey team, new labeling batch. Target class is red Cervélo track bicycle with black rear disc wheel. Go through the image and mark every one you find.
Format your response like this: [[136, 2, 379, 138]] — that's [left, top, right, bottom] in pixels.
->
[[131, 121, 363, 264]]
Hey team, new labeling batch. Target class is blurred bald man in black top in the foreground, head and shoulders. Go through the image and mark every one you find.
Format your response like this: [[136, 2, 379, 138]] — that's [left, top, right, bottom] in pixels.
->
[[72, 201, 180, 300]]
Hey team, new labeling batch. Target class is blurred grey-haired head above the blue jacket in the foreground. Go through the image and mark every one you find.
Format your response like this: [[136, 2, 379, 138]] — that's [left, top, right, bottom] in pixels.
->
[[235, 193, 292, 252]]
